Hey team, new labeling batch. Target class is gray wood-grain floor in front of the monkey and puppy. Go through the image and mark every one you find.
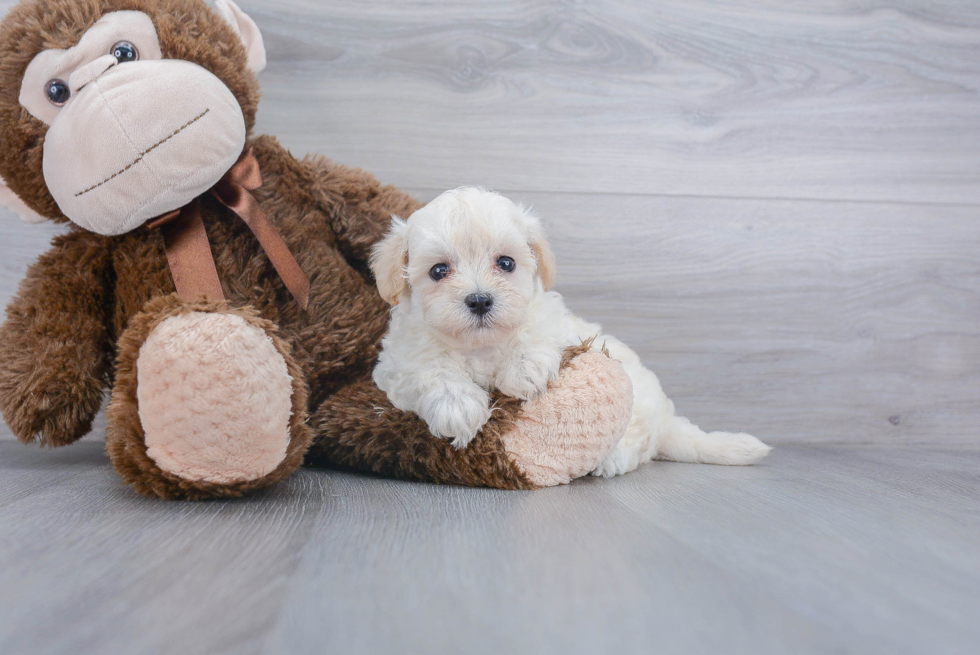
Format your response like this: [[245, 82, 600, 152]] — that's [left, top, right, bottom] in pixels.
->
[[0, 441, 980, 655]]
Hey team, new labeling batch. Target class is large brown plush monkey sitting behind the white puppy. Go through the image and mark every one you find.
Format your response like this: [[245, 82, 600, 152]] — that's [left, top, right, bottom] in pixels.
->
[[0, 0, 632, 499]]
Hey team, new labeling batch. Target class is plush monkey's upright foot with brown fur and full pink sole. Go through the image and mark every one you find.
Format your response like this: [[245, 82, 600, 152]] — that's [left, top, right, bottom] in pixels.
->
[[106, 295, 311, 500]]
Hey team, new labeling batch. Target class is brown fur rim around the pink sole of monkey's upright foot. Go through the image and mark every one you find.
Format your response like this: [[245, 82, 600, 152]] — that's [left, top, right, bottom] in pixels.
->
[[105, 295, 313, 500]]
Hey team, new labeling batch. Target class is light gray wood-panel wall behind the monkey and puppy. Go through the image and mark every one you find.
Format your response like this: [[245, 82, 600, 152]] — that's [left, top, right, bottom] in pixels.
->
[[0, 0, 980, 444]]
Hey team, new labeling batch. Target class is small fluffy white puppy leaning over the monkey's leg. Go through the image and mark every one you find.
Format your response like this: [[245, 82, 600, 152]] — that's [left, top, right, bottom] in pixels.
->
[[371, 187, 770, 476]]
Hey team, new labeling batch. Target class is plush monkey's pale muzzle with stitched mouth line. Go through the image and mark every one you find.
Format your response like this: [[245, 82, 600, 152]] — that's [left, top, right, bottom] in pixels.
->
[[43, 59, 245, 235]]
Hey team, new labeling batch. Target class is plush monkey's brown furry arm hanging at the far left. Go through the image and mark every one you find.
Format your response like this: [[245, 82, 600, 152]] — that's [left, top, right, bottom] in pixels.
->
[[0, 231, 112, 446]]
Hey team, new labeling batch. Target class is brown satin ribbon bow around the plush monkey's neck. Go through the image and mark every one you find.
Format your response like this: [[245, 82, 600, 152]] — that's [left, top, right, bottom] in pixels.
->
[[147, 148, 310, 309]]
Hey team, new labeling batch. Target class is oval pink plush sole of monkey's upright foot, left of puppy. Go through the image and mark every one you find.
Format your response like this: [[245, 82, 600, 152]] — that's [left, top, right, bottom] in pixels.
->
[[136, 312, 292, 484]]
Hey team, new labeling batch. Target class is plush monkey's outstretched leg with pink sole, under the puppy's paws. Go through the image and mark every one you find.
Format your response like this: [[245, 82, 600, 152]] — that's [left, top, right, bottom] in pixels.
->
[[306, 348, 633, 489]]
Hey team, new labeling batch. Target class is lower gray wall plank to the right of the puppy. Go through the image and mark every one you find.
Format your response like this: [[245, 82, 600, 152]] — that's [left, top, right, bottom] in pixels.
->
[[502, 193, 980, 444]]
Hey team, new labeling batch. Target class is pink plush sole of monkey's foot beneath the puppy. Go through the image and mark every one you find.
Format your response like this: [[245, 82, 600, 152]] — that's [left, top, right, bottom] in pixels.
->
[[503, 351, 633, 487]]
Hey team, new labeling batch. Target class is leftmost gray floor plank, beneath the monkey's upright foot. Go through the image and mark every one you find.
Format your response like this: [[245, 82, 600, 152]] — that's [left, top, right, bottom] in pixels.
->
[[0, 441, 330, 653]]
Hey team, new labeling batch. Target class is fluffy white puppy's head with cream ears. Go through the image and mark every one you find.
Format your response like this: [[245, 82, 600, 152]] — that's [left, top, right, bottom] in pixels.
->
[[371, 187, 555, 348]]
